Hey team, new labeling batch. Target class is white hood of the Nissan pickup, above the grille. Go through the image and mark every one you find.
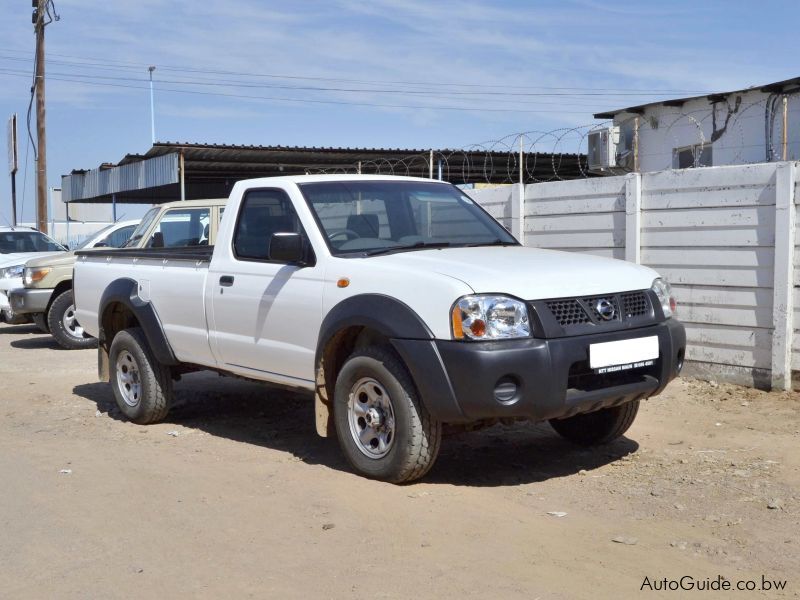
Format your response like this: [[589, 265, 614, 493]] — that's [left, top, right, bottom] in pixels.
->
[[366, 246, 658, 300]]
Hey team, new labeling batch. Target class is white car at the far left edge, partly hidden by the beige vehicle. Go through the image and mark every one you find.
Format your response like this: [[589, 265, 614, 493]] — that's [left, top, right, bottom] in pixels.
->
[[0, 226, 67, 327]]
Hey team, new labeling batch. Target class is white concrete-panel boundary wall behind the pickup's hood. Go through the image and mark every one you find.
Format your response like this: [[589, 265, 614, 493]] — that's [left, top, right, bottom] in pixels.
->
[[469, 162, 800, 389]]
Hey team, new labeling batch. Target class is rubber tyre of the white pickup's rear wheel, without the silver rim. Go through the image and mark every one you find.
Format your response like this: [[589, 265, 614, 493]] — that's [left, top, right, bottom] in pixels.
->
[[108, 327, 172, 425]]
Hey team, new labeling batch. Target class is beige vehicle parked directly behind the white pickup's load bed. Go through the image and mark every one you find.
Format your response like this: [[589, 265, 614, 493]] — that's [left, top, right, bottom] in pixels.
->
[[9, 199, 226, 349]]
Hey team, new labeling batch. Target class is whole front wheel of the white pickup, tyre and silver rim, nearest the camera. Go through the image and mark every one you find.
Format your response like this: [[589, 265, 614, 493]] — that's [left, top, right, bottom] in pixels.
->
[[333, 346, 442, 483]]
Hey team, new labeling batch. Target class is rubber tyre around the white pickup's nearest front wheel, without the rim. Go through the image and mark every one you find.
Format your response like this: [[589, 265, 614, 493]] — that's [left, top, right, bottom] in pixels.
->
[[333, 346, 442, 483]]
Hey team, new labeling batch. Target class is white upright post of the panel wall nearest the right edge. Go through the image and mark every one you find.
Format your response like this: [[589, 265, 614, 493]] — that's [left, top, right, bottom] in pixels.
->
[[771, 162, 796, 390]]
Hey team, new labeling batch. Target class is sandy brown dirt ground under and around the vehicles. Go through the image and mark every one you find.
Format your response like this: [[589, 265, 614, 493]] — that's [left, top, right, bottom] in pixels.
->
[[0, 325, 800, 600]]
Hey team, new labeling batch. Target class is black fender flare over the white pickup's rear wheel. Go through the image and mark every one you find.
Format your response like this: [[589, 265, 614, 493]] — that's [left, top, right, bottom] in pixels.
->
[[98, 277, 180, 366]]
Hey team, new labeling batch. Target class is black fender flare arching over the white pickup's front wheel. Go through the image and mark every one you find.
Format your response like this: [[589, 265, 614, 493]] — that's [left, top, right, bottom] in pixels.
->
[[314, 294, 464, 422]]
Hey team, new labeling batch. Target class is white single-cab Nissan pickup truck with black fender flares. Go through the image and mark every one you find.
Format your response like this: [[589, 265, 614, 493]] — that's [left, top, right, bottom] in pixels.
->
[[74, 175, 686, 482]]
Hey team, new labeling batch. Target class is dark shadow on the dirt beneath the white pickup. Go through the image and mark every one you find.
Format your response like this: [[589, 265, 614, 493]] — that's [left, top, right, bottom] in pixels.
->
[[73, 372, 639, 487]]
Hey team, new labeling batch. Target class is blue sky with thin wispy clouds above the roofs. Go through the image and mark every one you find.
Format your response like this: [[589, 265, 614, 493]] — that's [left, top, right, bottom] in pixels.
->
[[0, 0, 800, 219]]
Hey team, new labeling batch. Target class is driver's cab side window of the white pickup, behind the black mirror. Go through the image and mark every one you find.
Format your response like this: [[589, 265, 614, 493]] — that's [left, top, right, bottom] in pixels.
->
[[233, 190, 302, 260]]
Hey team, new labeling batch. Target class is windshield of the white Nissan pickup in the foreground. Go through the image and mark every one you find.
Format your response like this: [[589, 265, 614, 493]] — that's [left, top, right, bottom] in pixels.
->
[[299, 181, 517, 256]]
